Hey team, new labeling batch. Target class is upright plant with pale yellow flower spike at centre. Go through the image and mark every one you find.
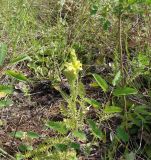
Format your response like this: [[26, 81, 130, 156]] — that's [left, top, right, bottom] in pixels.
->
[[62, 49, 86, 130]]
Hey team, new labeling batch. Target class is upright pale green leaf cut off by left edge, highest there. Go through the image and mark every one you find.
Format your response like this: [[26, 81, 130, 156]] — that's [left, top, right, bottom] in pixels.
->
[[0, 43, 7, 66]]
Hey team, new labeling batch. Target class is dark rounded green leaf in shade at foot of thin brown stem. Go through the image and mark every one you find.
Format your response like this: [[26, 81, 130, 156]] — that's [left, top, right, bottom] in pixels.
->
[[116, 127, 129, 142]]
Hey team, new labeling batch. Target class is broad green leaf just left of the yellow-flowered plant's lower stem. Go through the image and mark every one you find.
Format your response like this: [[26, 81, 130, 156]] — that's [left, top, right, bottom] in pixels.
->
[[46, 121, 68, 134]]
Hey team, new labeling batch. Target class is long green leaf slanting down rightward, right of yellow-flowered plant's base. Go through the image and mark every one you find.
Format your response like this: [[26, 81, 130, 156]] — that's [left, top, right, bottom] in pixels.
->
[[88, 119, 103, 139]]
